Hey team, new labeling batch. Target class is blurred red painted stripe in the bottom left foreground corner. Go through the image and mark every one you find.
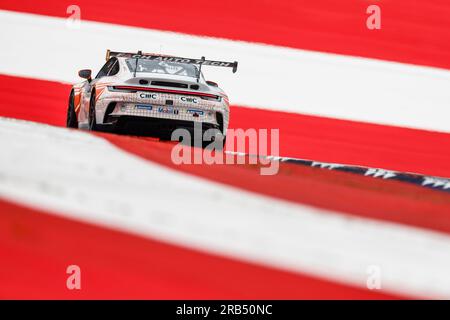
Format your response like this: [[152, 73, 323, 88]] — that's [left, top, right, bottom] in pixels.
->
[[0, 201, 396, 299]]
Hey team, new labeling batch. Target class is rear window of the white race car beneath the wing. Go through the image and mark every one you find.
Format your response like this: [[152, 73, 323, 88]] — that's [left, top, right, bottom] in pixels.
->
[[126, 58, 198, 78]]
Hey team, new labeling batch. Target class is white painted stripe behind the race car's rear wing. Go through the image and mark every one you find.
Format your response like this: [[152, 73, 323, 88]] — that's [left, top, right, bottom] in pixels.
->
[[0, 11, 450, 132]]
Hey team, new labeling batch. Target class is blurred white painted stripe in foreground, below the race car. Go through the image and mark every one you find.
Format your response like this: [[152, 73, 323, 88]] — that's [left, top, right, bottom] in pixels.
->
[[0, 118, 450, 298]]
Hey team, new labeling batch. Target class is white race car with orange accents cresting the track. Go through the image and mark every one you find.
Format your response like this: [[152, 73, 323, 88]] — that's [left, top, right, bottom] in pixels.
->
[[67, 50, 237, 144]]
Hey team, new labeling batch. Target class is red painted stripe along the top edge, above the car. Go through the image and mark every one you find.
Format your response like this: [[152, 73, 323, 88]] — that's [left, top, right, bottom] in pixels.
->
[[0, 0, 450, 68]]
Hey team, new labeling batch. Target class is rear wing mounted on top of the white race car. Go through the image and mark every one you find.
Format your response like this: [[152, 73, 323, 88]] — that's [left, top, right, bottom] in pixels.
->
[[106, 49, 238, 73]]
